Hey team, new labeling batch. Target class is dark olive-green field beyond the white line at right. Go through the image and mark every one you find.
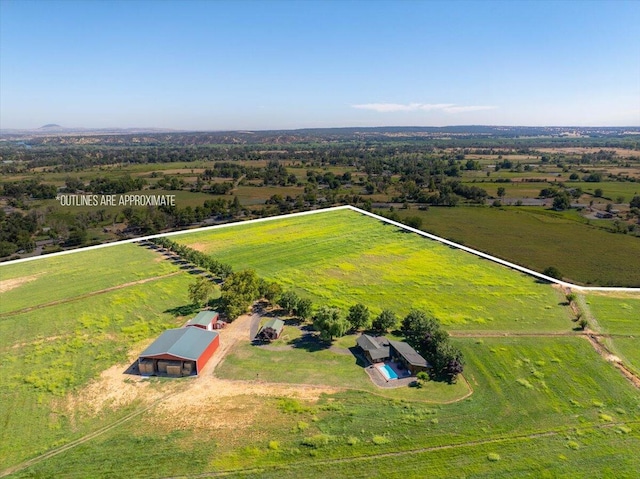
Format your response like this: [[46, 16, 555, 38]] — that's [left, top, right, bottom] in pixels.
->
[[397, 207, 640, 287]]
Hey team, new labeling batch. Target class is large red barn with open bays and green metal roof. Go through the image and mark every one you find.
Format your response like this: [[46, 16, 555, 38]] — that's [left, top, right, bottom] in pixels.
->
[[138, 327, 220, 376]]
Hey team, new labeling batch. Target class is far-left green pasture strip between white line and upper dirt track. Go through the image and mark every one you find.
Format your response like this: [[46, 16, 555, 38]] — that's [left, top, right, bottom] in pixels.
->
[[0, 244, 179, 316]]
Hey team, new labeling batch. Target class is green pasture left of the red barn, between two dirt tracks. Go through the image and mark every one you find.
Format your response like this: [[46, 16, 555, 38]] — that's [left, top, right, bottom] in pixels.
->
[[0, 272, 192, 468]]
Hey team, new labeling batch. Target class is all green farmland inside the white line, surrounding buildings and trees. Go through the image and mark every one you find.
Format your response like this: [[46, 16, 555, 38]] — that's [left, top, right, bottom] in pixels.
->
[[0, 210, 640, 478]]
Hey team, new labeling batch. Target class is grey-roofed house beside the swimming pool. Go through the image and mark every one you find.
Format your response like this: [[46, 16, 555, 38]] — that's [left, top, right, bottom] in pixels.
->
[[356, 334, 430, 375]]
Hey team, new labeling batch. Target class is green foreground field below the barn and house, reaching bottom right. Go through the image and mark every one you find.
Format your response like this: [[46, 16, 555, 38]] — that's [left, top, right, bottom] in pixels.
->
[[17, 337, 640, 478]]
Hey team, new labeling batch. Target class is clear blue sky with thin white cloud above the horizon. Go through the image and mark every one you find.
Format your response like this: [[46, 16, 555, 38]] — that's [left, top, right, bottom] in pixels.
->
[[0, 0, 640, 130]]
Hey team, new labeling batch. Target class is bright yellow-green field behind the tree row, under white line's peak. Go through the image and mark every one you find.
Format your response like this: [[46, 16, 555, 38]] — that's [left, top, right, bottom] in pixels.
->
[[173, 210, 571, 332]]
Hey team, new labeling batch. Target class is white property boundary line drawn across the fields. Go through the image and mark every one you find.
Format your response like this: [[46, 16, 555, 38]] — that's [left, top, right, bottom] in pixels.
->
[[0, 205, 640, 293]]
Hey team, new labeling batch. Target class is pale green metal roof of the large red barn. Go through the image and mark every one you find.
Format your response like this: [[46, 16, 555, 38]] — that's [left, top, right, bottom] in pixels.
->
[[140, 328, 218, 361]]
